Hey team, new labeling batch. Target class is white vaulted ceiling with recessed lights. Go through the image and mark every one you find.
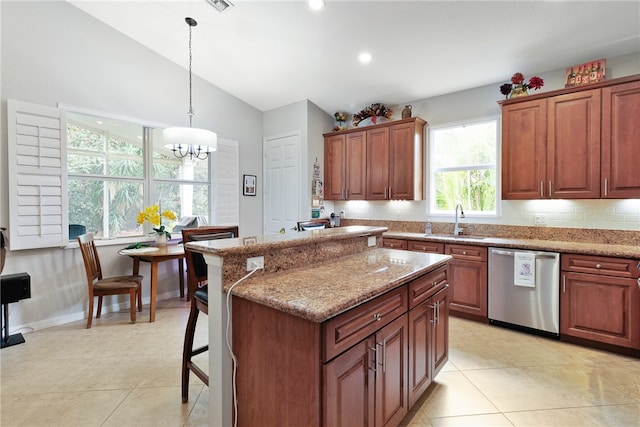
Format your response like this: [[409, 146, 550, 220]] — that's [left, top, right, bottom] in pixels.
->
[[67, 0, 640, 114]]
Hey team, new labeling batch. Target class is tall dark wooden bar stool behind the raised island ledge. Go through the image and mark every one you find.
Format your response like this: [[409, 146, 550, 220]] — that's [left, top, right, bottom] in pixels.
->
[[182, 226, 238, 403]]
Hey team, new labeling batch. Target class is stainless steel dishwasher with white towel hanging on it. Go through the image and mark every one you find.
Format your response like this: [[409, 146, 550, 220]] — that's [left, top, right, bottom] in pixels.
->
[[487, 248, 560, 337]]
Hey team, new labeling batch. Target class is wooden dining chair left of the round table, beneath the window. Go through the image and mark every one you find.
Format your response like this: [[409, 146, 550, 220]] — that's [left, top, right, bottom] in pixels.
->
[[78, 233, 143, 329]]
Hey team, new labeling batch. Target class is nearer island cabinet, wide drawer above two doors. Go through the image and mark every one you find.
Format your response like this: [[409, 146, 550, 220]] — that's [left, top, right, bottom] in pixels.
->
[[324, 286, 409, 426]]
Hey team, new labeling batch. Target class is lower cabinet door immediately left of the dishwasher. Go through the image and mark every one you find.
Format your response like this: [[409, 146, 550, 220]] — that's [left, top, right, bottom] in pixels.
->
[[449, 258, 487, 319]]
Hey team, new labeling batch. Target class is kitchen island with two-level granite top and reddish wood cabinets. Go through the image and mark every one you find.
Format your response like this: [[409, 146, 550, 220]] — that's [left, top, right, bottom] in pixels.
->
[[186, 226, 450, 426]]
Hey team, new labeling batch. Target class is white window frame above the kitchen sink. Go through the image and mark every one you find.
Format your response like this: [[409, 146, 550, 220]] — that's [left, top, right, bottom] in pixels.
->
[[425, 115, 502, 219]]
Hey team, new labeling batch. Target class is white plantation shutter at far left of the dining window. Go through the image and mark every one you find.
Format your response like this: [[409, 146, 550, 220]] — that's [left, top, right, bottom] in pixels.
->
[[7, 99, 69, 250]]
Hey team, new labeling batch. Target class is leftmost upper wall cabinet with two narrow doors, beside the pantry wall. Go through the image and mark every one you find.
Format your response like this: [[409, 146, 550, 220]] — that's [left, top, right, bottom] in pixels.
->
[[324, 131, 367, 200]]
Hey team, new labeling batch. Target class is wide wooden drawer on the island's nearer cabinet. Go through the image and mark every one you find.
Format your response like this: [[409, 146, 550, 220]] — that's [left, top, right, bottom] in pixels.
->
[[322, 286, 407, 362]]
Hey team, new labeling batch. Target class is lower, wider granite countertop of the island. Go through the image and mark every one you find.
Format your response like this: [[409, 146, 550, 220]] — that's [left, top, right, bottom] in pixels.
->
[[225, 248, 451, 323]]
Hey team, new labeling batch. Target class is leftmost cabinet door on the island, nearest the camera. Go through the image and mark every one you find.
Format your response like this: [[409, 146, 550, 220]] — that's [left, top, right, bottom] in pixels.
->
[[324, 338, 376, 427]]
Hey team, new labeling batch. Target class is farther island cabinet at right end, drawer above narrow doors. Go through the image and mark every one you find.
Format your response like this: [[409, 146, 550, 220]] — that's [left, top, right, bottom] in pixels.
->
[[409, 267, 449, 407]]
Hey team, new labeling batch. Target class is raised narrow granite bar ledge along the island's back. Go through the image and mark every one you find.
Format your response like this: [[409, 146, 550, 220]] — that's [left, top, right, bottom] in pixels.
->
[[185, 225, 387, 255]]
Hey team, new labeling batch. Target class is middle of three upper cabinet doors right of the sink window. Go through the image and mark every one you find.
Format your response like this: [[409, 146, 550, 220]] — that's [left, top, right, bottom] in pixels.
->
[[544, 89, 600, 199]]
